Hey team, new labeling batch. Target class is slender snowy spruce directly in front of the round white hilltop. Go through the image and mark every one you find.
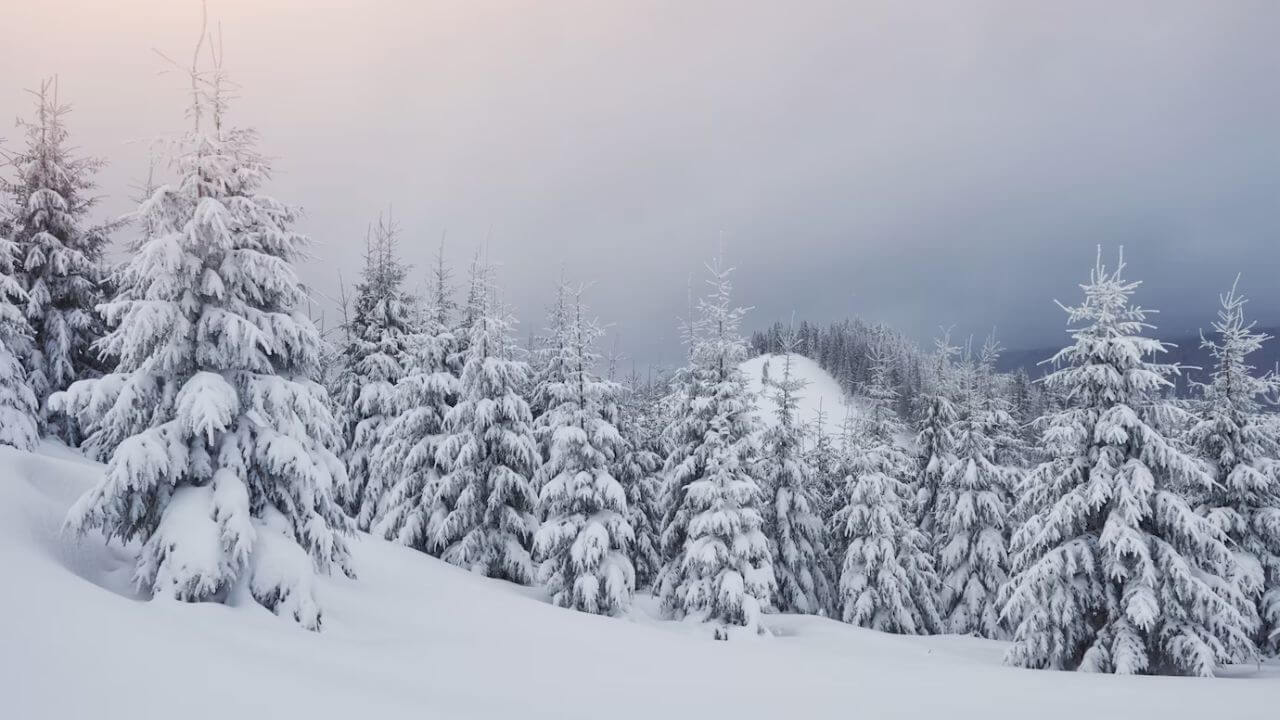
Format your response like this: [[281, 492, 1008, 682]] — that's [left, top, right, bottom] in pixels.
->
[[763, 329, 835, 615]]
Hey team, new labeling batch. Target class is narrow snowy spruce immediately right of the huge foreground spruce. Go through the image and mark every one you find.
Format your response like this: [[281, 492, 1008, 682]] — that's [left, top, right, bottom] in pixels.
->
[[338, 217, 415, 530]]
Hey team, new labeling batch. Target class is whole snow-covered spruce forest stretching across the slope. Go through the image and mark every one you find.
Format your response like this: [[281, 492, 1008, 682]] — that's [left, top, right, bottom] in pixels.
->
[[0, 9, 1280, 715]]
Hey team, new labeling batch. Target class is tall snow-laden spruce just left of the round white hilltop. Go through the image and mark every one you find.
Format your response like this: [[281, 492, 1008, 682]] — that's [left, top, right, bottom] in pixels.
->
[[658, 261, 776, 638]]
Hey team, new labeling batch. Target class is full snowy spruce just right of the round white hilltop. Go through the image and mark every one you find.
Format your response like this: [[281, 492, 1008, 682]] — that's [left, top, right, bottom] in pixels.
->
[[832, 346, 942, 634]]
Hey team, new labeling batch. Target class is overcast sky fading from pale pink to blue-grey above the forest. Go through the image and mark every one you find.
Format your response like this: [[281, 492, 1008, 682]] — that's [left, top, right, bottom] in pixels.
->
[[0, 0, 1280, 361]]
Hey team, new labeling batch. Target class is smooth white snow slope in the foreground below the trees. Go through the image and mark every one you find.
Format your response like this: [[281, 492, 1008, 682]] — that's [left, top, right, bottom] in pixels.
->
[[0, 446, 1280, 720]]
